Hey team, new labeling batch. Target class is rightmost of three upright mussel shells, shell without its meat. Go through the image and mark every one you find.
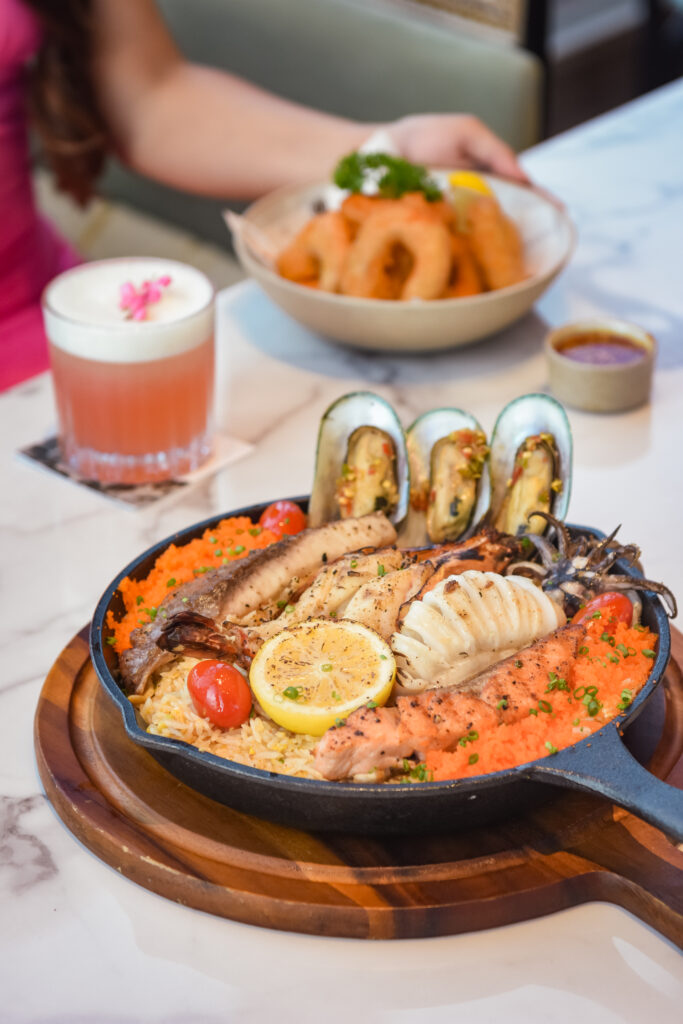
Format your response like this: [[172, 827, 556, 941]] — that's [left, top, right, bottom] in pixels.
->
[[486, 394, 572, 536]]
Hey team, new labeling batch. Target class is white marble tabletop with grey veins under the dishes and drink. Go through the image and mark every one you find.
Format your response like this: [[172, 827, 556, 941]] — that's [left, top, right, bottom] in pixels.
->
[[0, 77, 683, 1024]]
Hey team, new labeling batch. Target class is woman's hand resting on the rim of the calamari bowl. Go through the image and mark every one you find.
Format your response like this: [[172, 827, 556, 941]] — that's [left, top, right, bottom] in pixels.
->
[[385, 114, 529, 184]]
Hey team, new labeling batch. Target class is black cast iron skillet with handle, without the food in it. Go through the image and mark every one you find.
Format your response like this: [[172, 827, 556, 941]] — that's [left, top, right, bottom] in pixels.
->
[[90, 499, 683, 841]]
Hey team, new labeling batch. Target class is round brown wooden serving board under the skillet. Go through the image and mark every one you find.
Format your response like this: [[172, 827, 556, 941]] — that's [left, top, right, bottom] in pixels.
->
[[35, 629, 683, 946]]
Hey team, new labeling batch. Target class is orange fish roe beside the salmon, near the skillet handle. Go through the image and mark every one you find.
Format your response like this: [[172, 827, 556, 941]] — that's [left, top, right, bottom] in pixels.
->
[[425, 618, 657, 781]]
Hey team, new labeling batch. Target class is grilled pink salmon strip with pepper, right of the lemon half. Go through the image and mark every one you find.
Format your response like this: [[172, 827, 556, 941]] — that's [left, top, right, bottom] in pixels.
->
[[315, 626, 585, 779]]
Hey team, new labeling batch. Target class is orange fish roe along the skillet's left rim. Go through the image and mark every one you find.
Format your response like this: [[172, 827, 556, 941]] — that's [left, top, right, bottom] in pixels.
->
[[106, 516, 281, 653]]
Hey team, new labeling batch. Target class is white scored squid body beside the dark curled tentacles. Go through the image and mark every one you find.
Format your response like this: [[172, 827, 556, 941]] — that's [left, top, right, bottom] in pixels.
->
[[391, 569, 566, 692]]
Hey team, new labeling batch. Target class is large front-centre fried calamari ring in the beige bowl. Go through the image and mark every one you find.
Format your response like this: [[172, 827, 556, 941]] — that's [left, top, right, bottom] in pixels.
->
[[341, 205, 451, 300]]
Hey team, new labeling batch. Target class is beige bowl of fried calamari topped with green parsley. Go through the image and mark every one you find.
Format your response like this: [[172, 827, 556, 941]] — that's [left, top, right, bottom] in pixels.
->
[[228, 154, 574, 351]]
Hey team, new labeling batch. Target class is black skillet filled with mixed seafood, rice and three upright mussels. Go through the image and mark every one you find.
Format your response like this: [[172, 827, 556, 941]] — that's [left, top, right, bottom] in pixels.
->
[[90, 392, 683, 840]]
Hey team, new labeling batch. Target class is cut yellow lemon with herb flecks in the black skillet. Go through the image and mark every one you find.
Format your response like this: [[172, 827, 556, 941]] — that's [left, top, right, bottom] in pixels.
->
[[249, 618, 396, 736]]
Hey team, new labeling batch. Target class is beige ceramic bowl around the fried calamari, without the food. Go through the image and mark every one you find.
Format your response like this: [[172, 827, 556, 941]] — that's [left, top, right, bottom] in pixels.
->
[[234, 175, 574, 352]]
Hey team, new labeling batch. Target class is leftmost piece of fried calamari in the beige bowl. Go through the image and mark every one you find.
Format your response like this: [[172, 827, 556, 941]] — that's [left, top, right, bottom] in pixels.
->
[[276, 212, 351, 292]]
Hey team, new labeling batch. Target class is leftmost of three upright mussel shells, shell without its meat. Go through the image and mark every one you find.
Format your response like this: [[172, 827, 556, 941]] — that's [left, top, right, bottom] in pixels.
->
[[308, 391, 411, 526]]
